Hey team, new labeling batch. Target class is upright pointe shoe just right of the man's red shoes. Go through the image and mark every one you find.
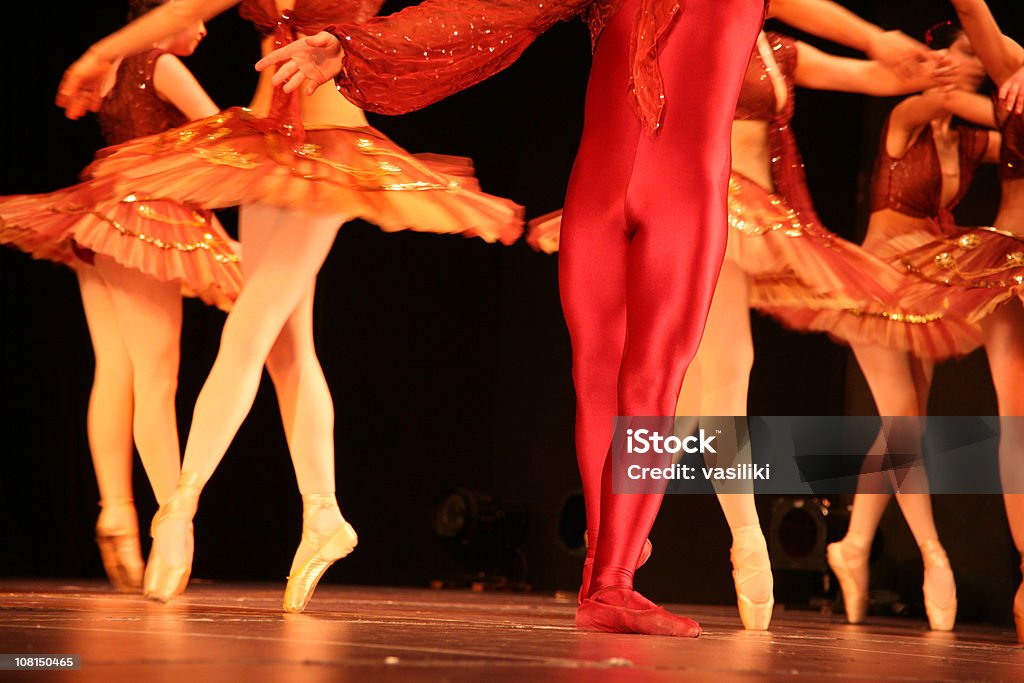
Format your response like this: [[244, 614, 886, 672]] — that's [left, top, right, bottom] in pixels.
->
[[729, 525, 775, 631]]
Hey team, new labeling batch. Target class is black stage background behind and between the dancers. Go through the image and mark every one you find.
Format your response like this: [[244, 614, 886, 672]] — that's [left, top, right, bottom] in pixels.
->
[[0, 0, 1024, 622]]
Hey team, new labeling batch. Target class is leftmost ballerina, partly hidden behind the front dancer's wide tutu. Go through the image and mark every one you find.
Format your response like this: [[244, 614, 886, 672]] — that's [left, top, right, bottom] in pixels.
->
[[0, 0, 242, 591]]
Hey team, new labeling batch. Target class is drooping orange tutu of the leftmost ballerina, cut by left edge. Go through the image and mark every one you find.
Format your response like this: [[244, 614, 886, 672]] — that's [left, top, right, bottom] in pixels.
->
[[0, 181, 242, 310]]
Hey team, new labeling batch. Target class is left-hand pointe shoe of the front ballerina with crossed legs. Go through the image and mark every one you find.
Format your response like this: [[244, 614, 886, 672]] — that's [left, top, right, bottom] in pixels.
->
[[142, 472, 200, 602]]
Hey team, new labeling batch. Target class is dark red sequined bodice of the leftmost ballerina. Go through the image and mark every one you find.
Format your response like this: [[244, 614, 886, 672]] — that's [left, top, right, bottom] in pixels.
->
[[97, 49, 187, 144]]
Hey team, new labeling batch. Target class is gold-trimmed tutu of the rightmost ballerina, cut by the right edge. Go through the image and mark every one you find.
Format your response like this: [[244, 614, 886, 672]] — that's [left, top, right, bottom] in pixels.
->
[[899, 227, 1024, 323]]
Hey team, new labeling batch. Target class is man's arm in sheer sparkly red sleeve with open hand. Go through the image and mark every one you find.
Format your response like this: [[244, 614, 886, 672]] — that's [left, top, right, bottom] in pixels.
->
[[256, 0, 590, 114]]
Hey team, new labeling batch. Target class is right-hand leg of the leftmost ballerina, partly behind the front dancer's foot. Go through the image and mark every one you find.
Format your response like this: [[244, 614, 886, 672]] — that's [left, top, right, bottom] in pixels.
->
[[96, 255, 181, 504]]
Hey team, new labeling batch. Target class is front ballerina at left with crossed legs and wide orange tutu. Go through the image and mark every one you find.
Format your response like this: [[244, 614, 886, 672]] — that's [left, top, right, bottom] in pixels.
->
[[57, 0, 521, 611]]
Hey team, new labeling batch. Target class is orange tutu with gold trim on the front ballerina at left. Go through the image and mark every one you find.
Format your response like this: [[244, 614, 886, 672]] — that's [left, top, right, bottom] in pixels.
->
[[87, 109, 522, 244]]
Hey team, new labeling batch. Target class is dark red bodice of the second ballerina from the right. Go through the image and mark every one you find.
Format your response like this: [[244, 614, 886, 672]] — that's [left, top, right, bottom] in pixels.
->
[[871, 116, 988, 218]]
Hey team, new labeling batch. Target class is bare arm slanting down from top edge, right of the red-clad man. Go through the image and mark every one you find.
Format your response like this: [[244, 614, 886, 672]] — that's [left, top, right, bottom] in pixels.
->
[[769, 0, 929, 78]]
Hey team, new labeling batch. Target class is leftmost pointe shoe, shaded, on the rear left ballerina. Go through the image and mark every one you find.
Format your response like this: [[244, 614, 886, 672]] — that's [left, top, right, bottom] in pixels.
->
[[96, 498, 143, 593]]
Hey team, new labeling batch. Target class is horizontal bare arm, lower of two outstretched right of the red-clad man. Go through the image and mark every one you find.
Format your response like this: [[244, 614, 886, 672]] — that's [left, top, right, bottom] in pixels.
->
[[794, 42, 955, 96]]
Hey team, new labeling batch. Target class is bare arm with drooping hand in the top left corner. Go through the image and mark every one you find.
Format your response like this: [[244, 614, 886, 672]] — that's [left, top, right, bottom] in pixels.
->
[[56, 0, 241, 119]]
